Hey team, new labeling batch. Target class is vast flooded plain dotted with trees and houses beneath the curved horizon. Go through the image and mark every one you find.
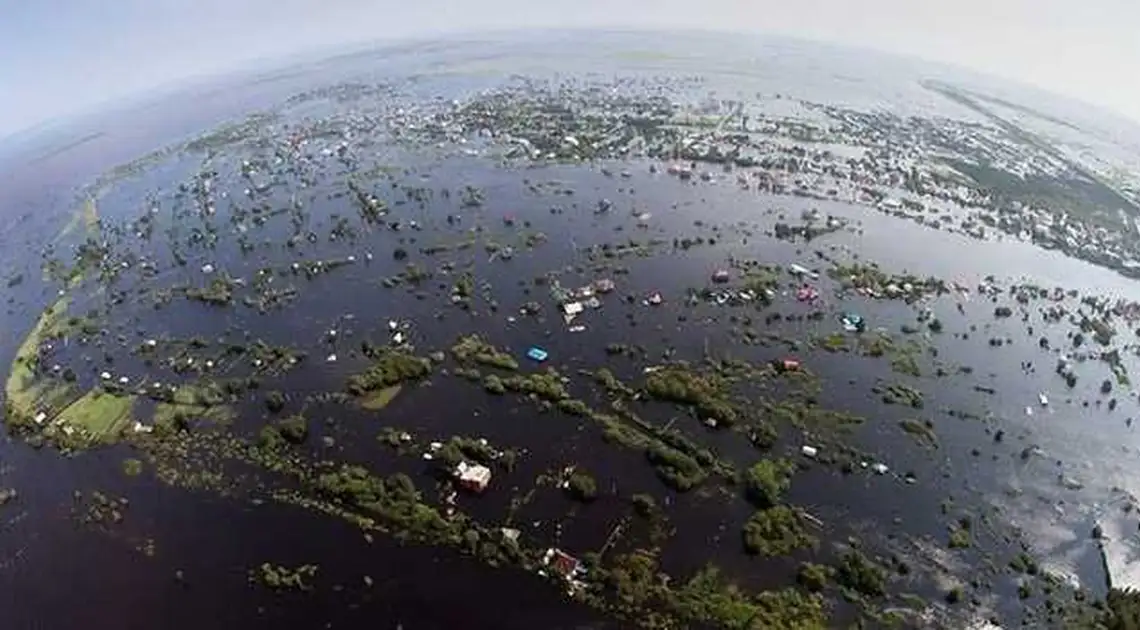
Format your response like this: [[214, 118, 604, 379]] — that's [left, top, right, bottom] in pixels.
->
[[0, 34, 1140, 629]]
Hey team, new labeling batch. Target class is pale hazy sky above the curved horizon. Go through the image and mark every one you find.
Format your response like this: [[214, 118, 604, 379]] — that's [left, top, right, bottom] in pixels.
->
[[0, 0, 1140, 137]]
